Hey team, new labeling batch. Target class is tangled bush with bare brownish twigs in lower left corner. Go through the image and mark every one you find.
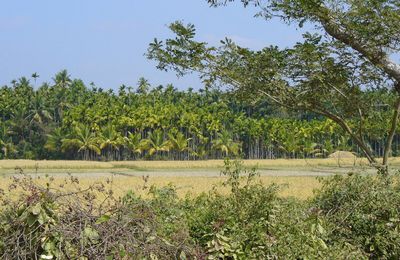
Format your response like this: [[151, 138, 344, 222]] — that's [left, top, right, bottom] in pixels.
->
[[0, 175, 197, 259]]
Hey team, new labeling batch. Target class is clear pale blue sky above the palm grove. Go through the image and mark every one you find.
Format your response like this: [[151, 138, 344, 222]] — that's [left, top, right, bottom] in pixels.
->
[[0, 0, 302, 89]]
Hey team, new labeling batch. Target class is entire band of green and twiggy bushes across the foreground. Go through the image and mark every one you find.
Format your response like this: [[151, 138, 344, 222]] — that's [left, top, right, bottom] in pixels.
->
[[0, 161, 400, 259]]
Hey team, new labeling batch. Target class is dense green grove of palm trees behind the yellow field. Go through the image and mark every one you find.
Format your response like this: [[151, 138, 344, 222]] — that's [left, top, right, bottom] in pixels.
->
[[0, 71, 398, 160]]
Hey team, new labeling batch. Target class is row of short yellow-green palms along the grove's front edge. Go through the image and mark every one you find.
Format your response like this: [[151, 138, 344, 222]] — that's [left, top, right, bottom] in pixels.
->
[[45, 124, 240, 160]]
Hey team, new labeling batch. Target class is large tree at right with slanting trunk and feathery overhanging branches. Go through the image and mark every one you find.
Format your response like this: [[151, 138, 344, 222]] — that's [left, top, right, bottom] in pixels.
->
[[148, 0, 400, 173]]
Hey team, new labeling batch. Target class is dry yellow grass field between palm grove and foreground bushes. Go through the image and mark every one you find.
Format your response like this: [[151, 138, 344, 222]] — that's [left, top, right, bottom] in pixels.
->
[[0, 158, 392, 199]]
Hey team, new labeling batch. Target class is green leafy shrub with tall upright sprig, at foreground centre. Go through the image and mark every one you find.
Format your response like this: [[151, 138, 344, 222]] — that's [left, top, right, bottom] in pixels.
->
[[186, 159, 366, 259]]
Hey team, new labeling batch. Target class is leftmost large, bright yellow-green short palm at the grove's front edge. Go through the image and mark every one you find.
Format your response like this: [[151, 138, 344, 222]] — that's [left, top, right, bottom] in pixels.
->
[[61, 125, 101, 160]]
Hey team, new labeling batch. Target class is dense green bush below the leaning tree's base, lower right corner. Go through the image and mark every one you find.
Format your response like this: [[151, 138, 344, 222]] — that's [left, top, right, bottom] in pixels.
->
[[312, 175, 400, 259]]
